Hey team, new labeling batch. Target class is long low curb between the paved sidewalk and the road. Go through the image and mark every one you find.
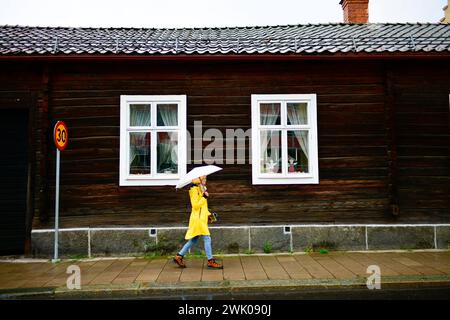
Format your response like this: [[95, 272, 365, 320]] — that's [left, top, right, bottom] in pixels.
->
[[0, 275, 450, 299]]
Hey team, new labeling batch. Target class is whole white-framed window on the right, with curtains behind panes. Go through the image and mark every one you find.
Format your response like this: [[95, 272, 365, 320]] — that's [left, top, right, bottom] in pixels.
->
[[252, 94, 319, 184]]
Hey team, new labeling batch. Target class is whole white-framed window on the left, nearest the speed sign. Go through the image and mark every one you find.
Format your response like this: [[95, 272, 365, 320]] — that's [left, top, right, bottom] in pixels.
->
[[119, 95, 187, 186]]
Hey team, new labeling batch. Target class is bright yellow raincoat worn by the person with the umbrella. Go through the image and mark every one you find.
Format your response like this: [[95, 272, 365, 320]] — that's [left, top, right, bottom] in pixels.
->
[[184, 186, 211, 240]]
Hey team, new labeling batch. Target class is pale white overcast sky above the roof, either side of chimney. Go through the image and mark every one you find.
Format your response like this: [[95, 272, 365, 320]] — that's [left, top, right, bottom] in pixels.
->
[[0, 0, 447, 28]]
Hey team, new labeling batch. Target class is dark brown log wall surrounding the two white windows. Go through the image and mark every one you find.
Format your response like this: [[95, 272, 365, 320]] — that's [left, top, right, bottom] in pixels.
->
[[0, 61, 450, 227]]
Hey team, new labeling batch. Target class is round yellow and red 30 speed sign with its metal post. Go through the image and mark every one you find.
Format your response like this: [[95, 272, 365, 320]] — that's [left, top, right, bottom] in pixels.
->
[[52, 121, 69, 263]]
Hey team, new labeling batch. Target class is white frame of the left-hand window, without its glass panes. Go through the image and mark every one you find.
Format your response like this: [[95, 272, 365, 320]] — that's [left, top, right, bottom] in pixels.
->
[[119, 95, 187, 186]]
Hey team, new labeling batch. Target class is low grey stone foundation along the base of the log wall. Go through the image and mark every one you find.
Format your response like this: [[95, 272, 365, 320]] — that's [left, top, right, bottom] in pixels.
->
[[32, 224, 450, 258]]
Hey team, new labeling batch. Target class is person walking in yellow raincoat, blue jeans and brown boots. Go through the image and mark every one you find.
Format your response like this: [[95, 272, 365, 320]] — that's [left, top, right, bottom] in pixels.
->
[[173, 176, 223, 269]]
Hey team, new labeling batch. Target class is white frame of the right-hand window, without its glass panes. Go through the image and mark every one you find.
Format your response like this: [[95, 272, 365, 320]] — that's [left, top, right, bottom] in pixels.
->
[[251, 94, 319, 185]]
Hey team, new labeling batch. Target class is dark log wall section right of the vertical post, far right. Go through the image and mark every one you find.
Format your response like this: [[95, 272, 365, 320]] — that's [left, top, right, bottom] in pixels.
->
[[393, 62, 450, 221]]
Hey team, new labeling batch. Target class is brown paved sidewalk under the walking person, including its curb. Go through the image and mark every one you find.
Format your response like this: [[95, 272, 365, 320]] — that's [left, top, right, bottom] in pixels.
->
[[0, 251, 450, 299]]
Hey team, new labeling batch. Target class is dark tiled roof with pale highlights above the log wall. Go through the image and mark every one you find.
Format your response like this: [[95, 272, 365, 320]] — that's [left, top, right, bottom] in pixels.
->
[[0, 23, 450, 56]]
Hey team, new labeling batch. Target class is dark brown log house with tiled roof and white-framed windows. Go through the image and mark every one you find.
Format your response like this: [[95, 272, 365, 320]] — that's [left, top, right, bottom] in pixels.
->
[[0, 0, 450, 254]]
